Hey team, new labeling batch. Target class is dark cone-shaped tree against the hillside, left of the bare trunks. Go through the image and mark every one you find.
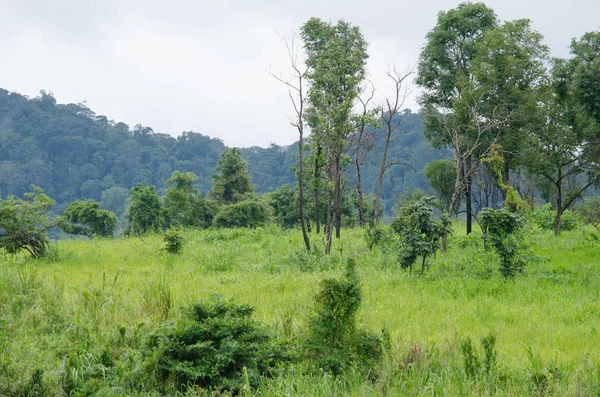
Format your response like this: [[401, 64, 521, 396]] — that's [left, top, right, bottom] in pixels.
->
[[208, 148, 254, 204]]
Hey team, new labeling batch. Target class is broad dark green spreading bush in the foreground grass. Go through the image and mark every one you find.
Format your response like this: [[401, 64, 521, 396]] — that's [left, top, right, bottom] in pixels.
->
[[142, 299, 288, 393]]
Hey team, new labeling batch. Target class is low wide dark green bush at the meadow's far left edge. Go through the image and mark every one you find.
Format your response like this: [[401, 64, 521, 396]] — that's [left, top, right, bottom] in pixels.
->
[[57, 201, 117, 238]]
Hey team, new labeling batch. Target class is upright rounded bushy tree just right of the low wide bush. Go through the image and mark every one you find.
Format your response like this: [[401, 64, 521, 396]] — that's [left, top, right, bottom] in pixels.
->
[[128, 184, 165, 234]]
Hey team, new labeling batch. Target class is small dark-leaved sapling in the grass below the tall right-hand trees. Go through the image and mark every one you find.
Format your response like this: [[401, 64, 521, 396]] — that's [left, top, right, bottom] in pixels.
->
[[392, 196, 451, 273]]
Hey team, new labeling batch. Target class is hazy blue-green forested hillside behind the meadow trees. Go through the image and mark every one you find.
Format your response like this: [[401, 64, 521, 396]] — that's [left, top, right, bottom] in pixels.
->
[[0, 90, 439, 215]]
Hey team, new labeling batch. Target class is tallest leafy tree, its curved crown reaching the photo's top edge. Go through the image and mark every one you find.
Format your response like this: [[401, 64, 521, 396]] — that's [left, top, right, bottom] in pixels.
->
[[416, 3, 498, 234]]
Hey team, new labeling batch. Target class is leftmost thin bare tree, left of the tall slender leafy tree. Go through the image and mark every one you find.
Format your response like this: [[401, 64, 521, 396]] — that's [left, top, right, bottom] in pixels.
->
[[268, 36, 310, 252]]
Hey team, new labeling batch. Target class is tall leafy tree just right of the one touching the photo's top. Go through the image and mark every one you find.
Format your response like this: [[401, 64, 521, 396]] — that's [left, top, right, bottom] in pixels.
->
[[470, 19, 549, 191]]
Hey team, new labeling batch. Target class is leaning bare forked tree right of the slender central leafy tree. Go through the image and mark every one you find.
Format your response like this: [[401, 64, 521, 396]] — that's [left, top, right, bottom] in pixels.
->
[[371, 66, 415, 227]]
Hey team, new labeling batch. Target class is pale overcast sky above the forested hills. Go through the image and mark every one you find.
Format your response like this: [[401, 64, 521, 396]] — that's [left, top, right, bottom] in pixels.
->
[[0, 0, 600, 147]]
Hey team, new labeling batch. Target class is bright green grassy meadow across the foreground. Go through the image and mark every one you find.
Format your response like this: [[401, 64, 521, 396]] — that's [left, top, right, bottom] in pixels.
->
[[0, 227, 600, 396]]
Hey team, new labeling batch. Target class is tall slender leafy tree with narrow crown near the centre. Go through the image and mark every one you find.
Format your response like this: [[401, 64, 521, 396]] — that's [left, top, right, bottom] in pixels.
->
[[300, 18, 368, 253]]
